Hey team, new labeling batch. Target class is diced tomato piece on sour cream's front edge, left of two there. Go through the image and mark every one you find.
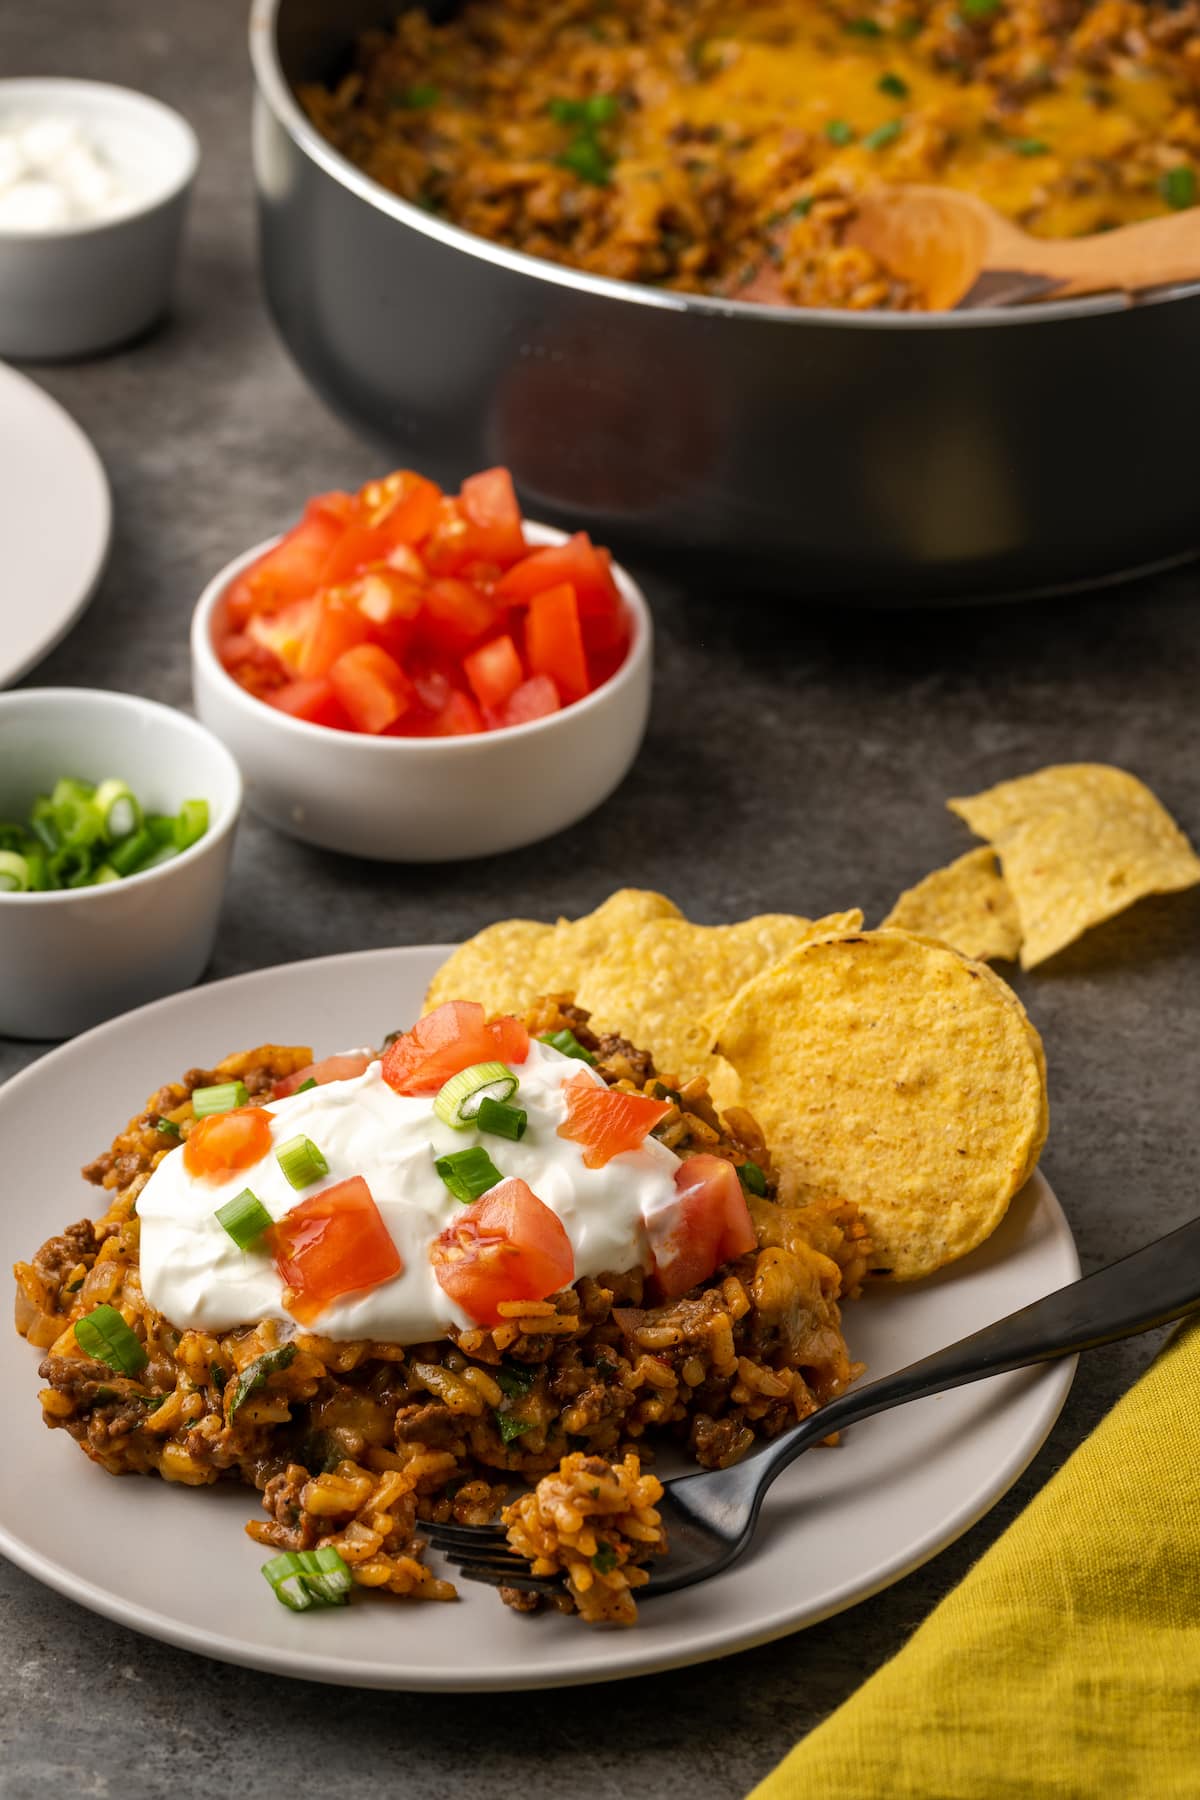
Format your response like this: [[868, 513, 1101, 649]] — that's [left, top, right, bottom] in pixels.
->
[[270, 1175, 405, 1325]]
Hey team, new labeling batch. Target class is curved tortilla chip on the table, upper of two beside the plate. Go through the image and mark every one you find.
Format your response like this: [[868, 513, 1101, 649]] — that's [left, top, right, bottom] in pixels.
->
[[946, 763, 1200, 968]]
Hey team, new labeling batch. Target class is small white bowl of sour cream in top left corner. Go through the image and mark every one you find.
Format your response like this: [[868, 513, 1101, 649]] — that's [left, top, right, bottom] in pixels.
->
[[0, 79, 200, 360]]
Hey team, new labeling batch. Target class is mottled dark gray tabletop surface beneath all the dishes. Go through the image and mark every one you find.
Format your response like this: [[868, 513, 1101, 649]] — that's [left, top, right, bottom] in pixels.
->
[[0, 0, 1200, 1800]]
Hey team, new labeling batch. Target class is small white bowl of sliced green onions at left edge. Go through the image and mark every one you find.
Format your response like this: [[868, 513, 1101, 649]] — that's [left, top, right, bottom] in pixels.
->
[[0, 688, 241, 1039]]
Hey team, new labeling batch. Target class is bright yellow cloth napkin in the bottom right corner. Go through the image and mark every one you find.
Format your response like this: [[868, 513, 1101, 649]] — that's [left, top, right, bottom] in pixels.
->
[[752, 1323, 1200, 1800]]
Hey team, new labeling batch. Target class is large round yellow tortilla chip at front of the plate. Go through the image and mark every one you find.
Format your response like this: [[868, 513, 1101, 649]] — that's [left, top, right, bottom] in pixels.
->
[[718, 931, 1047, 1280]]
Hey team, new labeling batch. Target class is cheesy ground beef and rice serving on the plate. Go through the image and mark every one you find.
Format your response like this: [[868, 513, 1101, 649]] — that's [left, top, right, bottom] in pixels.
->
[[16, 997, 871, 1622]]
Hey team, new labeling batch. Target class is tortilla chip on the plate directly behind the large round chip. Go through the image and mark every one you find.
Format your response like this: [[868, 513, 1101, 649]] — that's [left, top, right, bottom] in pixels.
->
[[576, 913, 862, 1080]]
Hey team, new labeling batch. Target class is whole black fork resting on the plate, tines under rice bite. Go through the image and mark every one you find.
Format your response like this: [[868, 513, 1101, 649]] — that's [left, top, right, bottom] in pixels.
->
[[423, 1219, 1200, 1600]]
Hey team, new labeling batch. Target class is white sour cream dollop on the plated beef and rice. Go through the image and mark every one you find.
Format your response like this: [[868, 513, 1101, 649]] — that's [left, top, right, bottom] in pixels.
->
[[137, 1042, 678, 1345]]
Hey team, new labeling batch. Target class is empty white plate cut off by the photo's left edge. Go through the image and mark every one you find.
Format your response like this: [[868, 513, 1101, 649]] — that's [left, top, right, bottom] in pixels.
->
[[0, 364, 112, 688]]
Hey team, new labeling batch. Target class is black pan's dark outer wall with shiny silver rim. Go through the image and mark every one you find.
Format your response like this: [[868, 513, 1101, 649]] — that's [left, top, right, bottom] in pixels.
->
[[252, 0, 1200, 603]]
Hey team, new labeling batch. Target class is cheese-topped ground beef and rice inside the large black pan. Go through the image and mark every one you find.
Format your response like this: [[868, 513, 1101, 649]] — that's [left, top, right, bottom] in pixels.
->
[[300, 0, 1200, 310]]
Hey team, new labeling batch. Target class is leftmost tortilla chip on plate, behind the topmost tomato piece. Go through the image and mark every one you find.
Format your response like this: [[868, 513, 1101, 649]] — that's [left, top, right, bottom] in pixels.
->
[[425, 887, 682, 1013]]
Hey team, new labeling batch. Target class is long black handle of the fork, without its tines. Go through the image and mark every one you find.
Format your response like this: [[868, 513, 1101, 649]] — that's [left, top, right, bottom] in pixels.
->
[[754, 1219, 1200, 1494]]
